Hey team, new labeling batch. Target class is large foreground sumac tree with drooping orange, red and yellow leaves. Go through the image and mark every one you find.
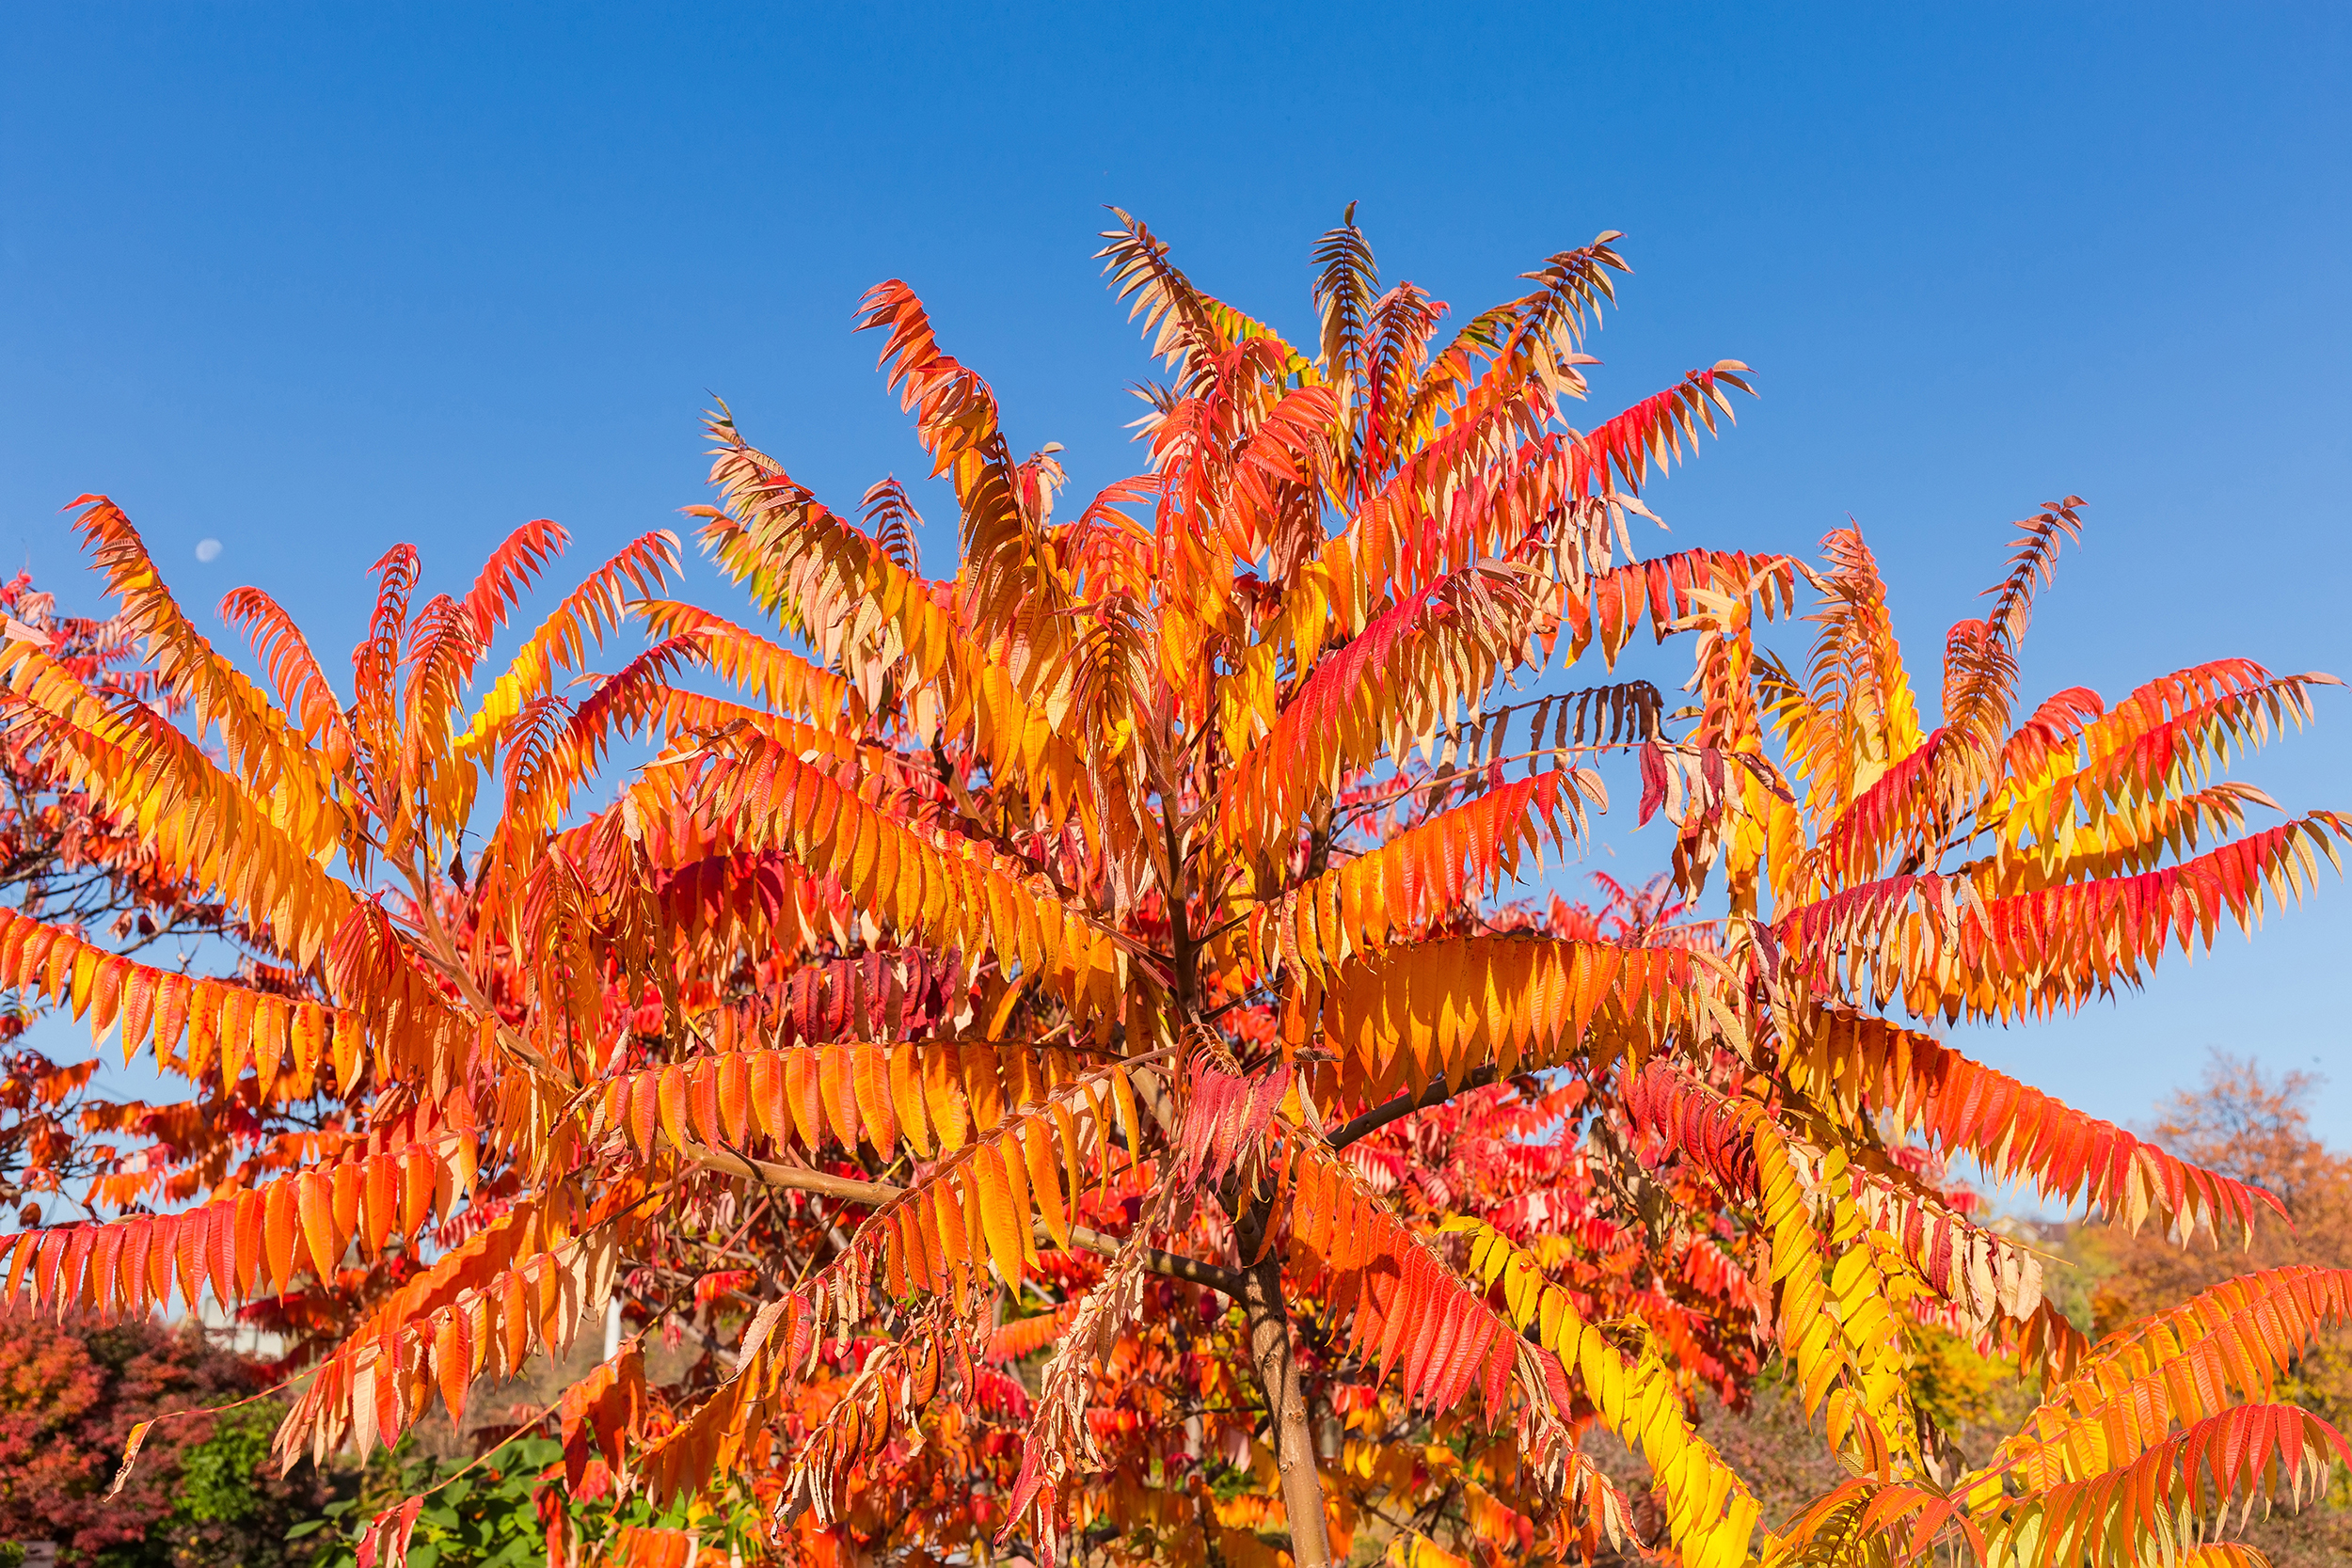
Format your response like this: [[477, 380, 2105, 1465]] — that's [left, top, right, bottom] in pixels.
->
[[0, 214, 2352, 1568]]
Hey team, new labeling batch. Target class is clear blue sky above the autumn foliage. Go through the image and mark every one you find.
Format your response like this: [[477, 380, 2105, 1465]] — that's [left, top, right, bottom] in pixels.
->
[[0, 0, 2352, 1143]]
